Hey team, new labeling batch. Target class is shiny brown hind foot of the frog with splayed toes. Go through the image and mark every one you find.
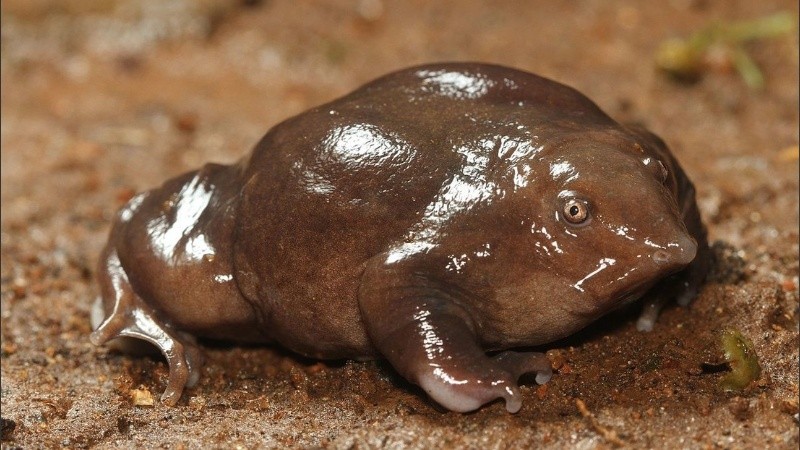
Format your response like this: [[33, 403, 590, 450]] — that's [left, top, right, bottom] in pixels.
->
[[89, 249, 203, 406]]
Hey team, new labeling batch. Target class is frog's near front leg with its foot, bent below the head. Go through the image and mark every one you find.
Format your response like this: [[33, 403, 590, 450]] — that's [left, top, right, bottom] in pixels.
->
[[359, 260, 552, 413]]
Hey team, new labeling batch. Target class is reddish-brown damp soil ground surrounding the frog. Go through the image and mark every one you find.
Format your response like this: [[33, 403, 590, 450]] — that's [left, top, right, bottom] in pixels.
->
[[0, 0, 798, 449]]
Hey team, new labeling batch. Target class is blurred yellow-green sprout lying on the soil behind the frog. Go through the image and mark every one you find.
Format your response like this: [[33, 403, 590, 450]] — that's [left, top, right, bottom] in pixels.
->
[[656, 12, 797, 89]]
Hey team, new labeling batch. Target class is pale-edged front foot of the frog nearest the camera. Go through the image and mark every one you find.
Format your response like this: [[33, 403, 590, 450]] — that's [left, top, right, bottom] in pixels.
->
[[417, 351, 553, 413]]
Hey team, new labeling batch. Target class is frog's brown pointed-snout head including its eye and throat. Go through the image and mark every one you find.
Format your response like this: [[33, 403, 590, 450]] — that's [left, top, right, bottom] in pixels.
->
[[484, 134, 697, 344]]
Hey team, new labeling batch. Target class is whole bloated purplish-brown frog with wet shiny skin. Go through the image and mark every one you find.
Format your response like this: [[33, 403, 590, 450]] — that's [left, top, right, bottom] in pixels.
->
[[92, 63, 708, 412]]
